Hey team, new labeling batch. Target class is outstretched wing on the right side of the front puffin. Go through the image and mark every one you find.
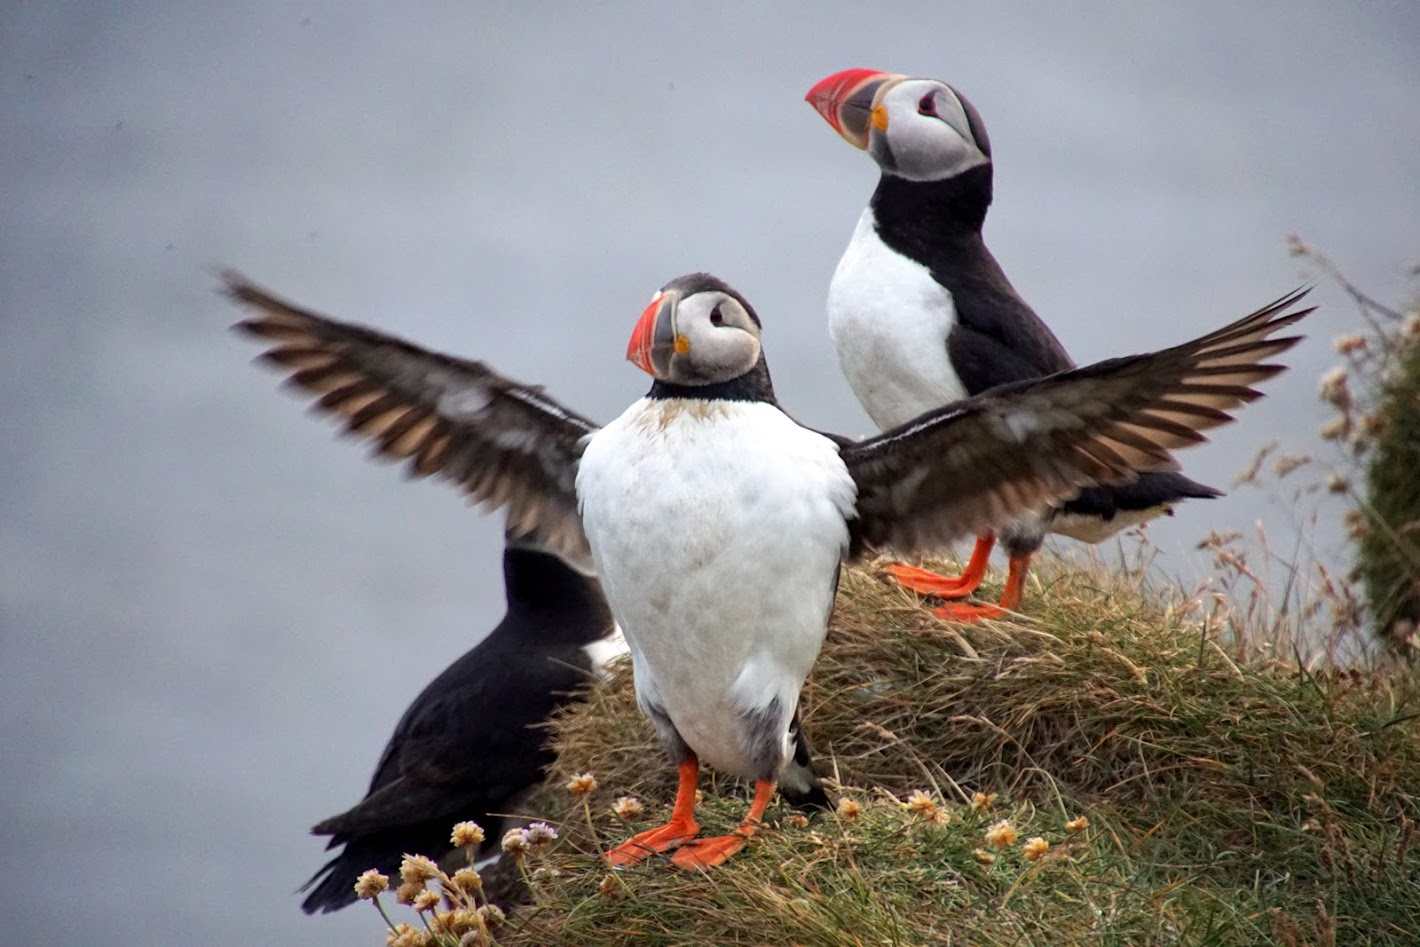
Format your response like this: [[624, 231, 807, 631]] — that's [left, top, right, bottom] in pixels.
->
[[843, 290, 1312, 552]]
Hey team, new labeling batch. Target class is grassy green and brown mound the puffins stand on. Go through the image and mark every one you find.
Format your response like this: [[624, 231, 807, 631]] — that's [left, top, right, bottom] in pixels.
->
[[498, 564, 1420, 947]]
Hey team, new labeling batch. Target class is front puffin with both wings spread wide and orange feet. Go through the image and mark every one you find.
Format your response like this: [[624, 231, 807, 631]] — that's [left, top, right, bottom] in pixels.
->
[[224, 273, 1309, 869]]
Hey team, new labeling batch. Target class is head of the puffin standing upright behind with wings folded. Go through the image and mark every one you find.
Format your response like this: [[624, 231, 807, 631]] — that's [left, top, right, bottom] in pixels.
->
[[804, 70, 991, 180]]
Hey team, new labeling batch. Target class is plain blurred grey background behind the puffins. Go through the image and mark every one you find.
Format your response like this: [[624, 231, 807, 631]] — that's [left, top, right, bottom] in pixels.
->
[[0, 0, 1420, 944]]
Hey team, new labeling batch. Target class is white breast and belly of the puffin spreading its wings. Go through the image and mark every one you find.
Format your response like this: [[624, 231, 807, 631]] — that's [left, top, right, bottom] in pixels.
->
[[577, 399, 856, 777]]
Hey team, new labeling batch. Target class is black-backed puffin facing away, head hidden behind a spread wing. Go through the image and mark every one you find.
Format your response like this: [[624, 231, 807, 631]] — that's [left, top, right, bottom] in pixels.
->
[[301, 534, 626, 914]]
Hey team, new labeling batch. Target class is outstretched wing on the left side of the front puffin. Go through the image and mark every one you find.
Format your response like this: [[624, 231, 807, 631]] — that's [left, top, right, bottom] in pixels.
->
[[222, 271, 598, 561]]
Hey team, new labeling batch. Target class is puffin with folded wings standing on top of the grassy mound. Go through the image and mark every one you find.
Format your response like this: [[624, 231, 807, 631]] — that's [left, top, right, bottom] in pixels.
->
[[805, 70, 1223, 622]]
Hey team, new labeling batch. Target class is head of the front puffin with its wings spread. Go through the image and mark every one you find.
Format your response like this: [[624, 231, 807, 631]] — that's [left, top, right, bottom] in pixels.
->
[[626, 273, 761, 386]]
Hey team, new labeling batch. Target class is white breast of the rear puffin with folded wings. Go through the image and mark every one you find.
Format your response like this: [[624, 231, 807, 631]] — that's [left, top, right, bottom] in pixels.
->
[[828, 207, 966, 429]]
